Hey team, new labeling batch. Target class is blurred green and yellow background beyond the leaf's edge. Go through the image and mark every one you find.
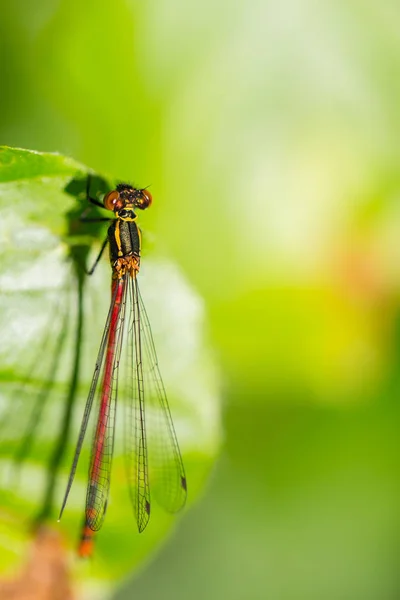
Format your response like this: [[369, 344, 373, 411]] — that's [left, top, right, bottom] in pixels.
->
[[0, 0, 400, 600]]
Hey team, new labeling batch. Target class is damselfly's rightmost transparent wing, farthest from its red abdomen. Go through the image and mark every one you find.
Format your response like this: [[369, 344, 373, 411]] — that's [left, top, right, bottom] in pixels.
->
[[137, 280, 187, 513]]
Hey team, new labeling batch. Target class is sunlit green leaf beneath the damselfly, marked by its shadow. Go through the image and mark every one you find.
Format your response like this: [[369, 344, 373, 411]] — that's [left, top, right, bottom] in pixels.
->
[[0, 147, 219, 581]]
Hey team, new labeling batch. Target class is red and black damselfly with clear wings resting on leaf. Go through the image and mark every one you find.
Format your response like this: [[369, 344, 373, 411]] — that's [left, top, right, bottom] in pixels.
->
[[60, 180, 187, 554]]
